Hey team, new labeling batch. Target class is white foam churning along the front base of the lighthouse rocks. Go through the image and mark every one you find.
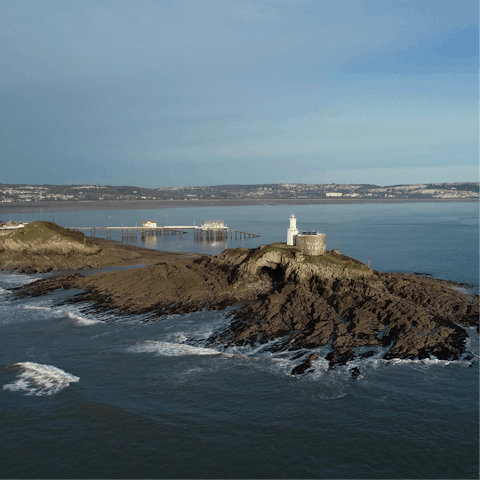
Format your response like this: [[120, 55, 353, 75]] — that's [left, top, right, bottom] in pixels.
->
[[128, 312, 480, 380]]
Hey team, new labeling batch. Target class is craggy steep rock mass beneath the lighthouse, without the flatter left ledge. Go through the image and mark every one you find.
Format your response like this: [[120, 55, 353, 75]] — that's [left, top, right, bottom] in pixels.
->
[[205, 246, 479, 366]]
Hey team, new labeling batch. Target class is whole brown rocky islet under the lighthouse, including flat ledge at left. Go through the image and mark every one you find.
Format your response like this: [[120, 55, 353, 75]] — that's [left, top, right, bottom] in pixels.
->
[[4, 223, 480, 375]]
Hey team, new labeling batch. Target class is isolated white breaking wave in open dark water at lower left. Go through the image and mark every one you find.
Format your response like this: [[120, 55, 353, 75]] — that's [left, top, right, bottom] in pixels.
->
[[3, 362, 80, 397]]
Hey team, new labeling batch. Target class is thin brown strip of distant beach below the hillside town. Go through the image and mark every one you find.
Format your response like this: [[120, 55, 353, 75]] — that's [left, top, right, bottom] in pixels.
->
[[0, 198, 478, 215]]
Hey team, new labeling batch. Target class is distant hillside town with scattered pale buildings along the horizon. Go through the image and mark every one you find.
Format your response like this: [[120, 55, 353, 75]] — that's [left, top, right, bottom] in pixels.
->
[[0, 182, 479, 203]]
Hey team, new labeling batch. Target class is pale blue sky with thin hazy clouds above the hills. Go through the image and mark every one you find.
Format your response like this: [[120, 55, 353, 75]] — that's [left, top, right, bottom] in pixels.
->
[[0, 0, 480, 188]]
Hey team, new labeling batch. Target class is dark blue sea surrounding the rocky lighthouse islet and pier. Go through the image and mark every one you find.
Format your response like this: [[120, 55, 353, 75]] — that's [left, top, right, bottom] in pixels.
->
[[0, 202, 480, 480]]
